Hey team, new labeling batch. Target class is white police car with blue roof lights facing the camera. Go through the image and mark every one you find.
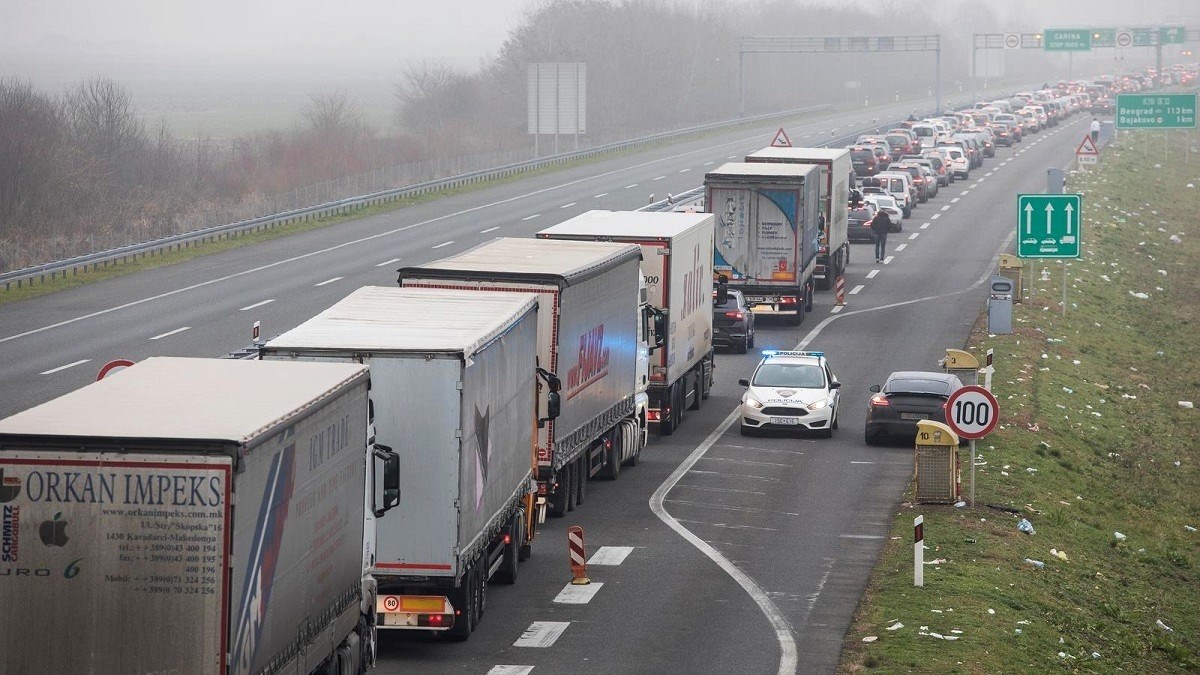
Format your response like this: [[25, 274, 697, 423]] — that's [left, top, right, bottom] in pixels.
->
[[738, 350, 841, 438]]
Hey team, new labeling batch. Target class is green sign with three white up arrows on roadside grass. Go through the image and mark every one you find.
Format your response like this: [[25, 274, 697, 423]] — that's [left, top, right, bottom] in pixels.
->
[[1016, 195, 1084, 258]]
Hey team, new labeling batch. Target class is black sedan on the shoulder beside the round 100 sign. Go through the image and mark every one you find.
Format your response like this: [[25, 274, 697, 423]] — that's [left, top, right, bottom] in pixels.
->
[[864, 370, 962, 446]]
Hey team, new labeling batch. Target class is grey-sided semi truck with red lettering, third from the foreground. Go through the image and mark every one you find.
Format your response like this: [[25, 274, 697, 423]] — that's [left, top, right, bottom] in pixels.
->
[[398, 238, 648, 521]]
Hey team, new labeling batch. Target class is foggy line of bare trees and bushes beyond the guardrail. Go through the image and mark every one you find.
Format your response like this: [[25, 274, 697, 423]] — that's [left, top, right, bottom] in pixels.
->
[[0, 0, 1060, 270]]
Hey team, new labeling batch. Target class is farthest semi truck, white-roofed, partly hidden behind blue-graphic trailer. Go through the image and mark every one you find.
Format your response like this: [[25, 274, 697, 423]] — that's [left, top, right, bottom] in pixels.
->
[[746, 147, 854, 291]]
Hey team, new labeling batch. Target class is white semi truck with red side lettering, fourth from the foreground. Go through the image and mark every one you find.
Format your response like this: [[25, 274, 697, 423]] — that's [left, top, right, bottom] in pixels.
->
[[538, 210, 714, 436]]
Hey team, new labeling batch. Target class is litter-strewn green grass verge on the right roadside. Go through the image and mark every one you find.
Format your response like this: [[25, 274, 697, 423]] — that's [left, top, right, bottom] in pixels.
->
[[839, 132, 1200, 674]]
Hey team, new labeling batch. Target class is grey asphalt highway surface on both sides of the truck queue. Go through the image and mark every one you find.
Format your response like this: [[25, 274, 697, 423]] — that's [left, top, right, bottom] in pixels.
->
[[0, 90, 1086, 673]]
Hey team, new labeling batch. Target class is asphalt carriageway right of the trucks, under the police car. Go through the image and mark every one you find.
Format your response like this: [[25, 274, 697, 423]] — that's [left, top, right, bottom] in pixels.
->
[[369, 117, 1086, 673]]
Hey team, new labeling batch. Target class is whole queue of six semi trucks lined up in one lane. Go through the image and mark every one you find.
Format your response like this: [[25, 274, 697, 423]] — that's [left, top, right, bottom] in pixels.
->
[[0, 140, 864, 674]]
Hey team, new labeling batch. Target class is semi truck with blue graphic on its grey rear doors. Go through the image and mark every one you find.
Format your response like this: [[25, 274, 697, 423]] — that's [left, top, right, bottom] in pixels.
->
[[704, 162, 820, 324]]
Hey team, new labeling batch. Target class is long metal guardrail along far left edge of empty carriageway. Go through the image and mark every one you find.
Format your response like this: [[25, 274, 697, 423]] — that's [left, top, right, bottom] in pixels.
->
[[0, 103, 834, 291]]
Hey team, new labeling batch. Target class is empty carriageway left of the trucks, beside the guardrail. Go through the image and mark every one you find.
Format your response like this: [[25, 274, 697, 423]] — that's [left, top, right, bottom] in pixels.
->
[[0, 89, 1032, 416]]
